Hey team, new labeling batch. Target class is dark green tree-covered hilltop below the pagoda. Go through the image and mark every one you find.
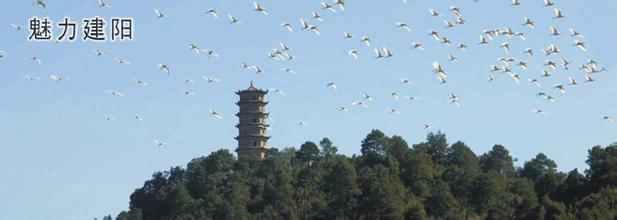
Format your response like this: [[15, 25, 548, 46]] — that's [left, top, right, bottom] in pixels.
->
[[105, 130, 617, 220]]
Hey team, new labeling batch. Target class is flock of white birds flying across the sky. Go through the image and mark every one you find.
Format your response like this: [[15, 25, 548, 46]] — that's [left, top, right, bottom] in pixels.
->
[[0, 0, 615, 146]]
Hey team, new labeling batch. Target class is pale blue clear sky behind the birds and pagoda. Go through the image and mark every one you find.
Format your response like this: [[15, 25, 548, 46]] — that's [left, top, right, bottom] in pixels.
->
[[0, 0, 617, 219]]
